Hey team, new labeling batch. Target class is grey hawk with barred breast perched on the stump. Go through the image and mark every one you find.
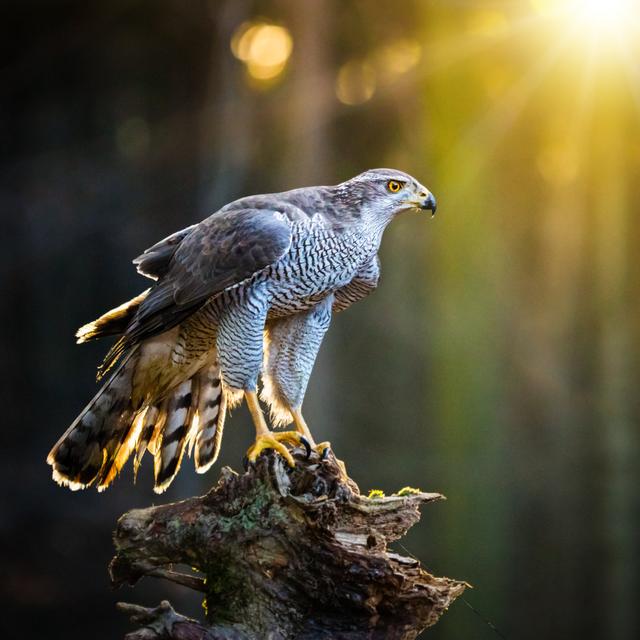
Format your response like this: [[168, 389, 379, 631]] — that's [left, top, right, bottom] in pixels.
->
[[47, 169, 436, 493]]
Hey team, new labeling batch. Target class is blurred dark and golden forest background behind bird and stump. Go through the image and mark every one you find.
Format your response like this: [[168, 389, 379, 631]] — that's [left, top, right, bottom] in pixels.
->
[[0, 0, 640, 640]]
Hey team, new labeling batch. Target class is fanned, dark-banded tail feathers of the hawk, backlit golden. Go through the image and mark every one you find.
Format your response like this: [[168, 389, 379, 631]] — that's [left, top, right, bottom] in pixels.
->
[[47, 352, 226, 493]]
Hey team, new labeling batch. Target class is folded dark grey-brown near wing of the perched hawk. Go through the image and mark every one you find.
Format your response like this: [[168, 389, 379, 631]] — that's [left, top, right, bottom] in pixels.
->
[[101, 209, 291, 373]]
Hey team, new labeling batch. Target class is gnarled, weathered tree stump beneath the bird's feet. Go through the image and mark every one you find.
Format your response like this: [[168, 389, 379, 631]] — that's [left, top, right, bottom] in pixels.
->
[[110, 450, 466, 640]]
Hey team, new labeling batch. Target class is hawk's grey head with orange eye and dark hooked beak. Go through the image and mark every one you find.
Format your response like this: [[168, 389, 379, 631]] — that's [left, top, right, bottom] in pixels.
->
[[341, 169, 436, 217]]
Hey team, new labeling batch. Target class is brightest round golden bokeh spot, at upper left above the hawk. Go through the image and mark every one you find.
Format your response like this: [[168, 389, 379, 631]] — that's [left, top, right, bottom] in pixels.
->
[[231, 21, 293, 82]]
